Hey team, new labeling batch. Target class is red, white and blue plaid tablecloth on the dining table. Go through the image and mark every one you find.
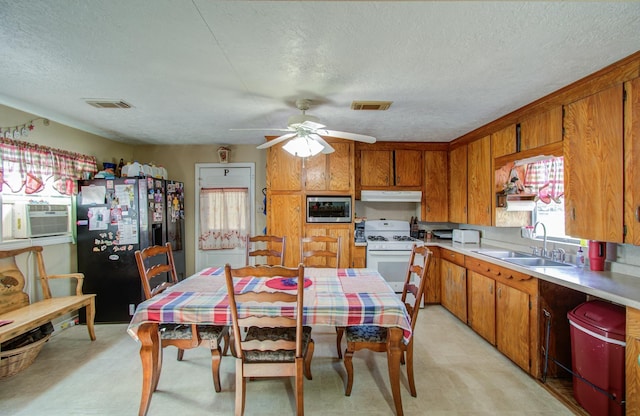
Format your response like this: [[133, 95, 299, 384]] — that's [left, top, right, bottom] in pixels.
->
[[127, 267, 411, 342]]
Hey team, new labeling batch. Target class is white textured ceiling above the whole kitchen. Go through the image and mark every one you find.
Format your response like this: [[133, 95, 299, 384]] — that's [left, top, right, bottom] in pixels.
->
[[0, 0, 640, 144]]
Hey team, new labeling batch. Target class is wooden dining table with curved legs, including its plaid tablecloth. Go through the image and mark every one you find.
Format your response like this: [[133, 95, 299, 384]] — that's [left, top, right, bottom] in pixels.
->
[[127, 266, 412, 416]]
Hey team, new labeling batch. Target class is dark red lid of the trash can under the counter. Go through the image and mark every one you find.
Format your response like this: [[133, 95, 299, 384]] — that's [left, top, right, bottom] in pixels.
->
[[567, 300, 626, 341]]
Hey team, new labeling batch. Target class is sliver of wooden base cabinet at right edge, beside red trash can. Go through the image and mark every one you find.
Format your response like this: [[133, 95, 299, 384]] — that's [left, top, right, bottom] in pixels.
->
[[625, 307, 640, 416]]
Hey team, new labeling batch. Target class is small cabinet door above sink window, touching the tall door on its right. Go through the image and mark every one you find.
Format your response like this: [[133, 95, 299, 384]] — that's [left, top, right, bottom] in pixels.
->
[[520, 106, 562, 151]]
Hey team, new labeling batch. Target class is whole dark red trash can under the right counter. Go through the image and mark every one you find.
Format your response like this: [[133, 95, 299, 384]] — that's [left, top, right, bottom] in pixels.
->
[[567, 300, 626, 416]]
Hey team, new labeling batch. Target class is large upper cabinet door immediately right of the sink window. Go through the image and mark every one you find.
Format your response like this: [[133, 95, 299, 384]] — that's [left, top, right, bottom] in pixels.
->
[[564, 85, 623, 243]]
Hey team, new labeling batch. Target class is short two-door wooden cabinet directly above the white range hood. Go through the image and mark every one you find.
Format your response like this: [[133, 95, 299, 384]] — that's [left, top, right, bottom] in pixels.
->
[[359, 149, 424, 190]]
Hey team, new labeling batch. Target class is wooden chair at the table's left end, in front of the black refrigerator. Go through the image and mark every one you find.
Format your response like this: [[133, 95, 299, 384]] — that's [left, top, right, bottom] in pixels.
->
[[135, 243, 229, 392]]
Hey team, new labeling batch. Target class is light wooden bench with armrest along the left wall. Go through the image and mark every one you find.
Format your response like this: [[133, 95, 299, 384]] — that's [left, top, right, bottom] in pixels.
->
[[0, 246, 96, 342]]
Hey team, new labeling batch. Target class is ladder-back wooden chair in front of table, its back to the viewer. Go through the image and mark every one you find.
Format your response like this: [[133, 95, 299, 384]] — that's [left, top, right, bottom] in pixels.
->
[[225, 264, 314, 416]]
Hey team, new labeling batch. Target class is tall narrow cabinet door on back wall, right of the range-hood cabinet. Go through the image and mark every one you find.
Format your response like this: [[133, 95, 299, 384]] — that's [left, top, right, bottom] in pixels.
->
[[422, 151, 449, 222]]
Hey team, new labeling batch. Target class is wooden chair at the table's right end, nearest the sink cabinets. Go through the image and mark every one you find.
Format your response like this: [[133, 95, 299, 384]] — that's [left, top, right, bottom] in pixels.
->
[[338, 245, 433, 402]]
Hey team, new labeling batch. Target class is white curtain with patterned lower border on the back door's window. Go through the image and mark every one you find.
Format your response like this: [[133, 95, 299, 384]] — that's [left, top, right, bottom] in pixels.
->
[[198, 188, 250, 250]]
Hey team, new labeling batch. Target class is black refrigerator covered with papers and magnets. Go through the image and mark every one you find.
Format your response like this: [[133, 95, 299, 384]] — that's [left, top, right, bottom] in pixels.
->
[[76, 178, 185, 322]]
